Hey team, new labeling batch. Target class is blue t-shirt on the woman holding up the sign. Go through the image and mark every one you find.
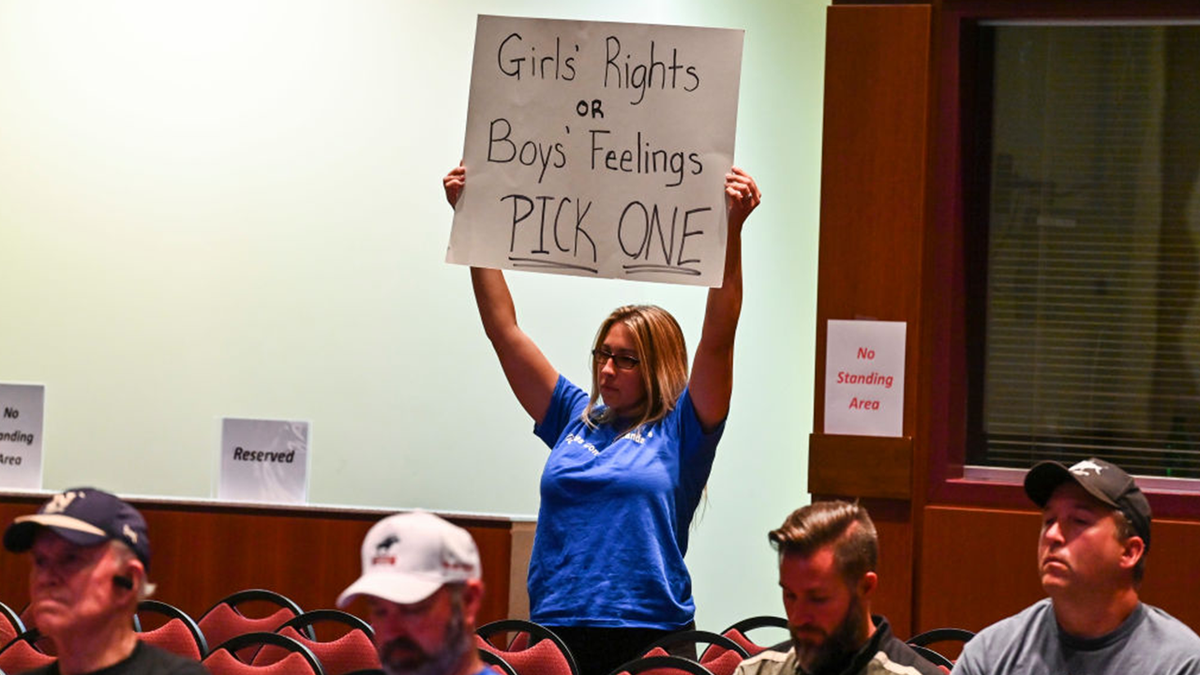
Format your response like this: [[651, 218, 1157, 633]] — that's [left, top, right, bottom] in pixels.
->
[[529, 376, 725, 629]]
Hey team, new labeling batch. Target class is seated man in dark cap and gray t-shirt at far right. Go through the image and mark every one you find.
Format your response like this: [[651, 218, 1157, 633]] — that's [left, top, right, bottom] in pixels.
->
[[954, 458, 1200, 675]]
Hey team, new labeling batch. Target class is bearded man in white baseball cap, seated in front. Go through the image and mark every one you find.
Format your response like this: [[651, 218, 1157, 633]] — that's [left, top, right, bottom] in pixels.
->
[[337, 512, 486, 675]]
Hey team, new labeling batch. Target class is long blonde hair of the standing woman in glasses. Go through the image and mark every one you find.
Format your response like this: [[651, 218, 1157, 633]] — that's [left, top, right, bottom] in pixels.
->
[[583, 305, 688, 431]]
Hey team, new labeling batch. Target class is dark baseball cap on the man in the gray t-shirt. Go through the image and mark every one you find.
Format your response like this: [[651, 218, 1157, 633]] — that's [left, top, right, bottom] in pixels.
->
[[1025, 458, 1151, 551]]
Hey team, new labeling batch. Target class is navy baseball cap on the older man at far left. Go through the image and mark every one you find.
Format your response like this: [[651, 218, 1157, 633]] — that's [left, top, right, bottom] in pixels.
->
[[4, 488, 150, 571]]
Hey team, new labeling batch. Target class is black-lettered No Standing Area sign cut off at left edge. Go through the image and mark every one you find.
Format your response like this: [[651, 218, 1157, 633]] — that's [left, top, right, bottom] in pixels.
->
[[0, 384, 46, 490]]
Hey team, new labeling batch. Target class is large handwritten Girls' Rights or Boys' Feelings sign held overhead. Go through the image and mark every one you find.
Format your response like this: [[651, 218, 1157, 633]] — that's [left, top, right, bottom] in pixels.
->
[[446, 16, 744, 286]]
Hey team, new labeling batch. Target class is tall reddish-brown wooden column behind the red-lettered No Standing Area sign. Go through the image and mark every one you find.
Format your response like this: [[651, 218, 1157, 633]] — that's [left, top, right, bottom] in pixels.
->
[[809, 5, 931, 635]]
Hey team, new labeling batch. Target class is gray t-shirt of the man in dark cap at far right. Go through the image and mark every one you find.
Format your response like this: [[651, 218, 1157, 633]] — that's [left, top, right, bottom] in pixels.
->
[[953, 598, 1200, 675]]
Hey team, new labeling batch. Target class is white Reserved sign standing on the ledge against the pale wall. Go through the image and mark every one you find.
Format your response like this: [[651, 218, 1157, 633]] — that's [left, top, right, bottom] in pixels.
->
[[217, 417, 308, 503]]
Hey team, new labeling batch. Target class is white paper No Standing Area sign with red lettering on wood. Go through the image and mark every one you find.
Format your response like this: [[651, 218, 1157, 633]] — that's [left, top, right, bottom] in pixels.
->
[[824, 319, 907, 436]]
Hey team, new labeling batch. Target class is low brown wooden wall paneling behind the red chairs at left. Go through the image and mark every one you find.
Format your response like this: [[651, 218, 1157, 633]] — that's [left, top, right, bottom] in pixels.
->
[[0, 496, 533, 623]]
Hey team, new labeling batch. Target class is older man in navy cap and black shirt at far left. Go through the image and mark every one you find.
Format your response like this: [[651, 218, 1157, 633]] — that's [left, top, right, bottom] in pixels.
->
[[4, 488, 208, 675]]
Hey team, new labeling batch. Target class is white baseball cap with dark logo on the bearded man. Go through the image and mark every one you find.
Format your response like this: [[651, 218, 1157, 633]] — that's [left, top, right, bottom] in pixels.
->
[[337, 510, 480, 608]]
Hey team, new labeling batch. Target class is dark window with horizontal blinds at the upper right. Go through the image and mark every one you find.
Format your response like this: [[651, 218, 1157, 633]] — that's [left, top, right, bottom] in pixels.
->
[[966, 23, 1200, 478]]
